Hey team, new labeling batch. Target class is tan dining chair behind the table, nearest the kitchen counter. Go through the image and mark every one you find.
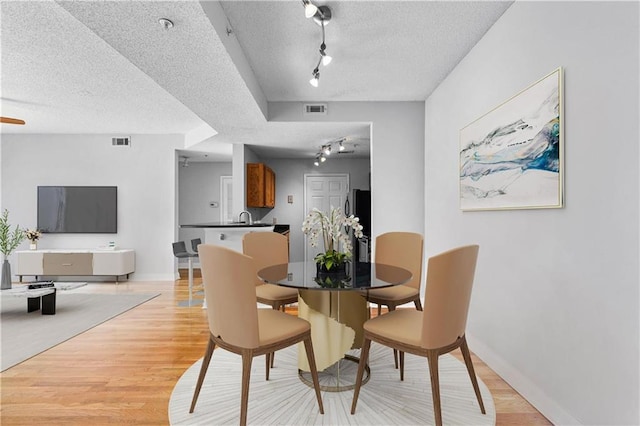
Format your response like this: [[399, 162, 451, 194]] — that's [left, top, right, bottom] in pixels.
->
[[242, 232, 298, 310]]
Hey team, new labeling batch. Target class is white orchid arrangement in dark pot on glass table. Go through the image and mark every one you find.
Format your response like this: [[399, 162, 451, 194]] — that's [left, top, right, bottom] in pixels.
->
[[302, 207, 362, 273]]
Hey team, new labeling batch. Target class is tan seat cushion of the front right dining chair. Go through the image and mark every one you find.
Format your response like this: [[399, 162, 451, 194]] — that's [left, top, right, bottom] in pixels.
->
[[364, 309, 423, 347]]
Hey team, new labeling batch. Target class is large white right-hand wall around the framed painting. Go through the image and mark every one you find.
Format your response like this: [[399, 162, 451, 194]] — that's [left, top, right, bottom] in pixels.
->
[[425, 2, 640, 425]]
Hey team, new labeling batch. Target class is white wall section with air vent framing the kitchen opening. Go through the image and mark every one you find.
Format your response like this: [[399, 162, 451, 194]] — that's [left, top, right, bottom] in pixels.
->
[[269, 102, 424, 240]]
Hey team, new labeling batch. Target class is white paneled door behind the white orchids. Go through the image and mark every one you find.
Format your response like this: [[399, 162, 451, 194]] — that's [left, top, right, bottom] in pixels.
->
[[304, 174, 349, 260]]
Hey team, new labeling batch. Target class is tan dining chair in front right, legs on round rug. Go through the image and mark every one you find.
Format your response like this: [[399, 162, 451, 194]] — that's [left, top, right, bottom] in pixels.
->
[[351, 245, 485, 425]]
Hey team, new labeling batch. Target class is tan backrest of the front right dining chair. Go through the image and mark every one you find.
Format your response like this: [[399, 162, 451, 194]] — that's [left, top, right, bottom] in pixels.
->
[[422, 245, 479, 349]]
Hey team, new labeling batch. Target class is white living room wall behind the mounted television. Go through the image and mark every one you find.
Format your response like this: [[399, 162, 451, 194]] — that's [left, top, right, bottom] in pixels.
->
[[1, 135, 184, 281]]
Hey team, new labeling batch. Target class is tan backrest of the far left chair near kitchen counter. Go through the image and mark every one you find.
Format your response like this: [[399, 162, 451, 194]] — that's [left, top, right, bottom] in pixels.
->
[[242, 232, 289, 285]]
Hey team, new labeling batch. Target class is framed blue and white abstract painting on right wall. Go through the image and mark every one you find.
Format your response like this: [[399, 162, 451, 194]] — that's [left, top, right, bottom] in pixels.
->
[[460, 68, 563, 210]]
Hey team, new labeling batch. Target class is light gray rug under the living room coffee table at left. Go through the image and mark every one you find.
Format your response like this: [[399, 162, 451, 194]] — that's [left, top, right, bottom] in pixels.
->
[[0, 291, 158, 371]]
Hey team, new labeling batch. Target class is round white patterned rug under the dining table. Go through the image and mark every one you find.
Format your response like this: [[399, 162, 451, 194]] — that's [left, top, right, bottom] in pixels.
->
[[169, 343, 496, 425]]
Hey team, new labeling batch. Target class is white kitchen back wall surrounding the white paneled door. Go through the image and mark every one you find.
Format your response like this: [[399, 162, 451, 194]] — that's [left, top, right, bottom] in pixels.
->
[[260, 158, 369, 261]]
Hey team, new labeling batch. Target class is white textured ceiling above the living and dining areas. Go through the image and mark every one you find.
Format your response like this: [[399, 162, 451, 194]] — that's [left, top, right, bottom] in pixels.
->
[[0, 0, 511, 157]]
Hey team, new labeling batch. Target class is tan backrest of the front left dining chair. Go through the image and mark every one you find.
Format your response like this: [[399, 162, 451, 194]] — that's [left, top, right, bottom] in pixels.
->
[[198, 244, 260, 349]]
